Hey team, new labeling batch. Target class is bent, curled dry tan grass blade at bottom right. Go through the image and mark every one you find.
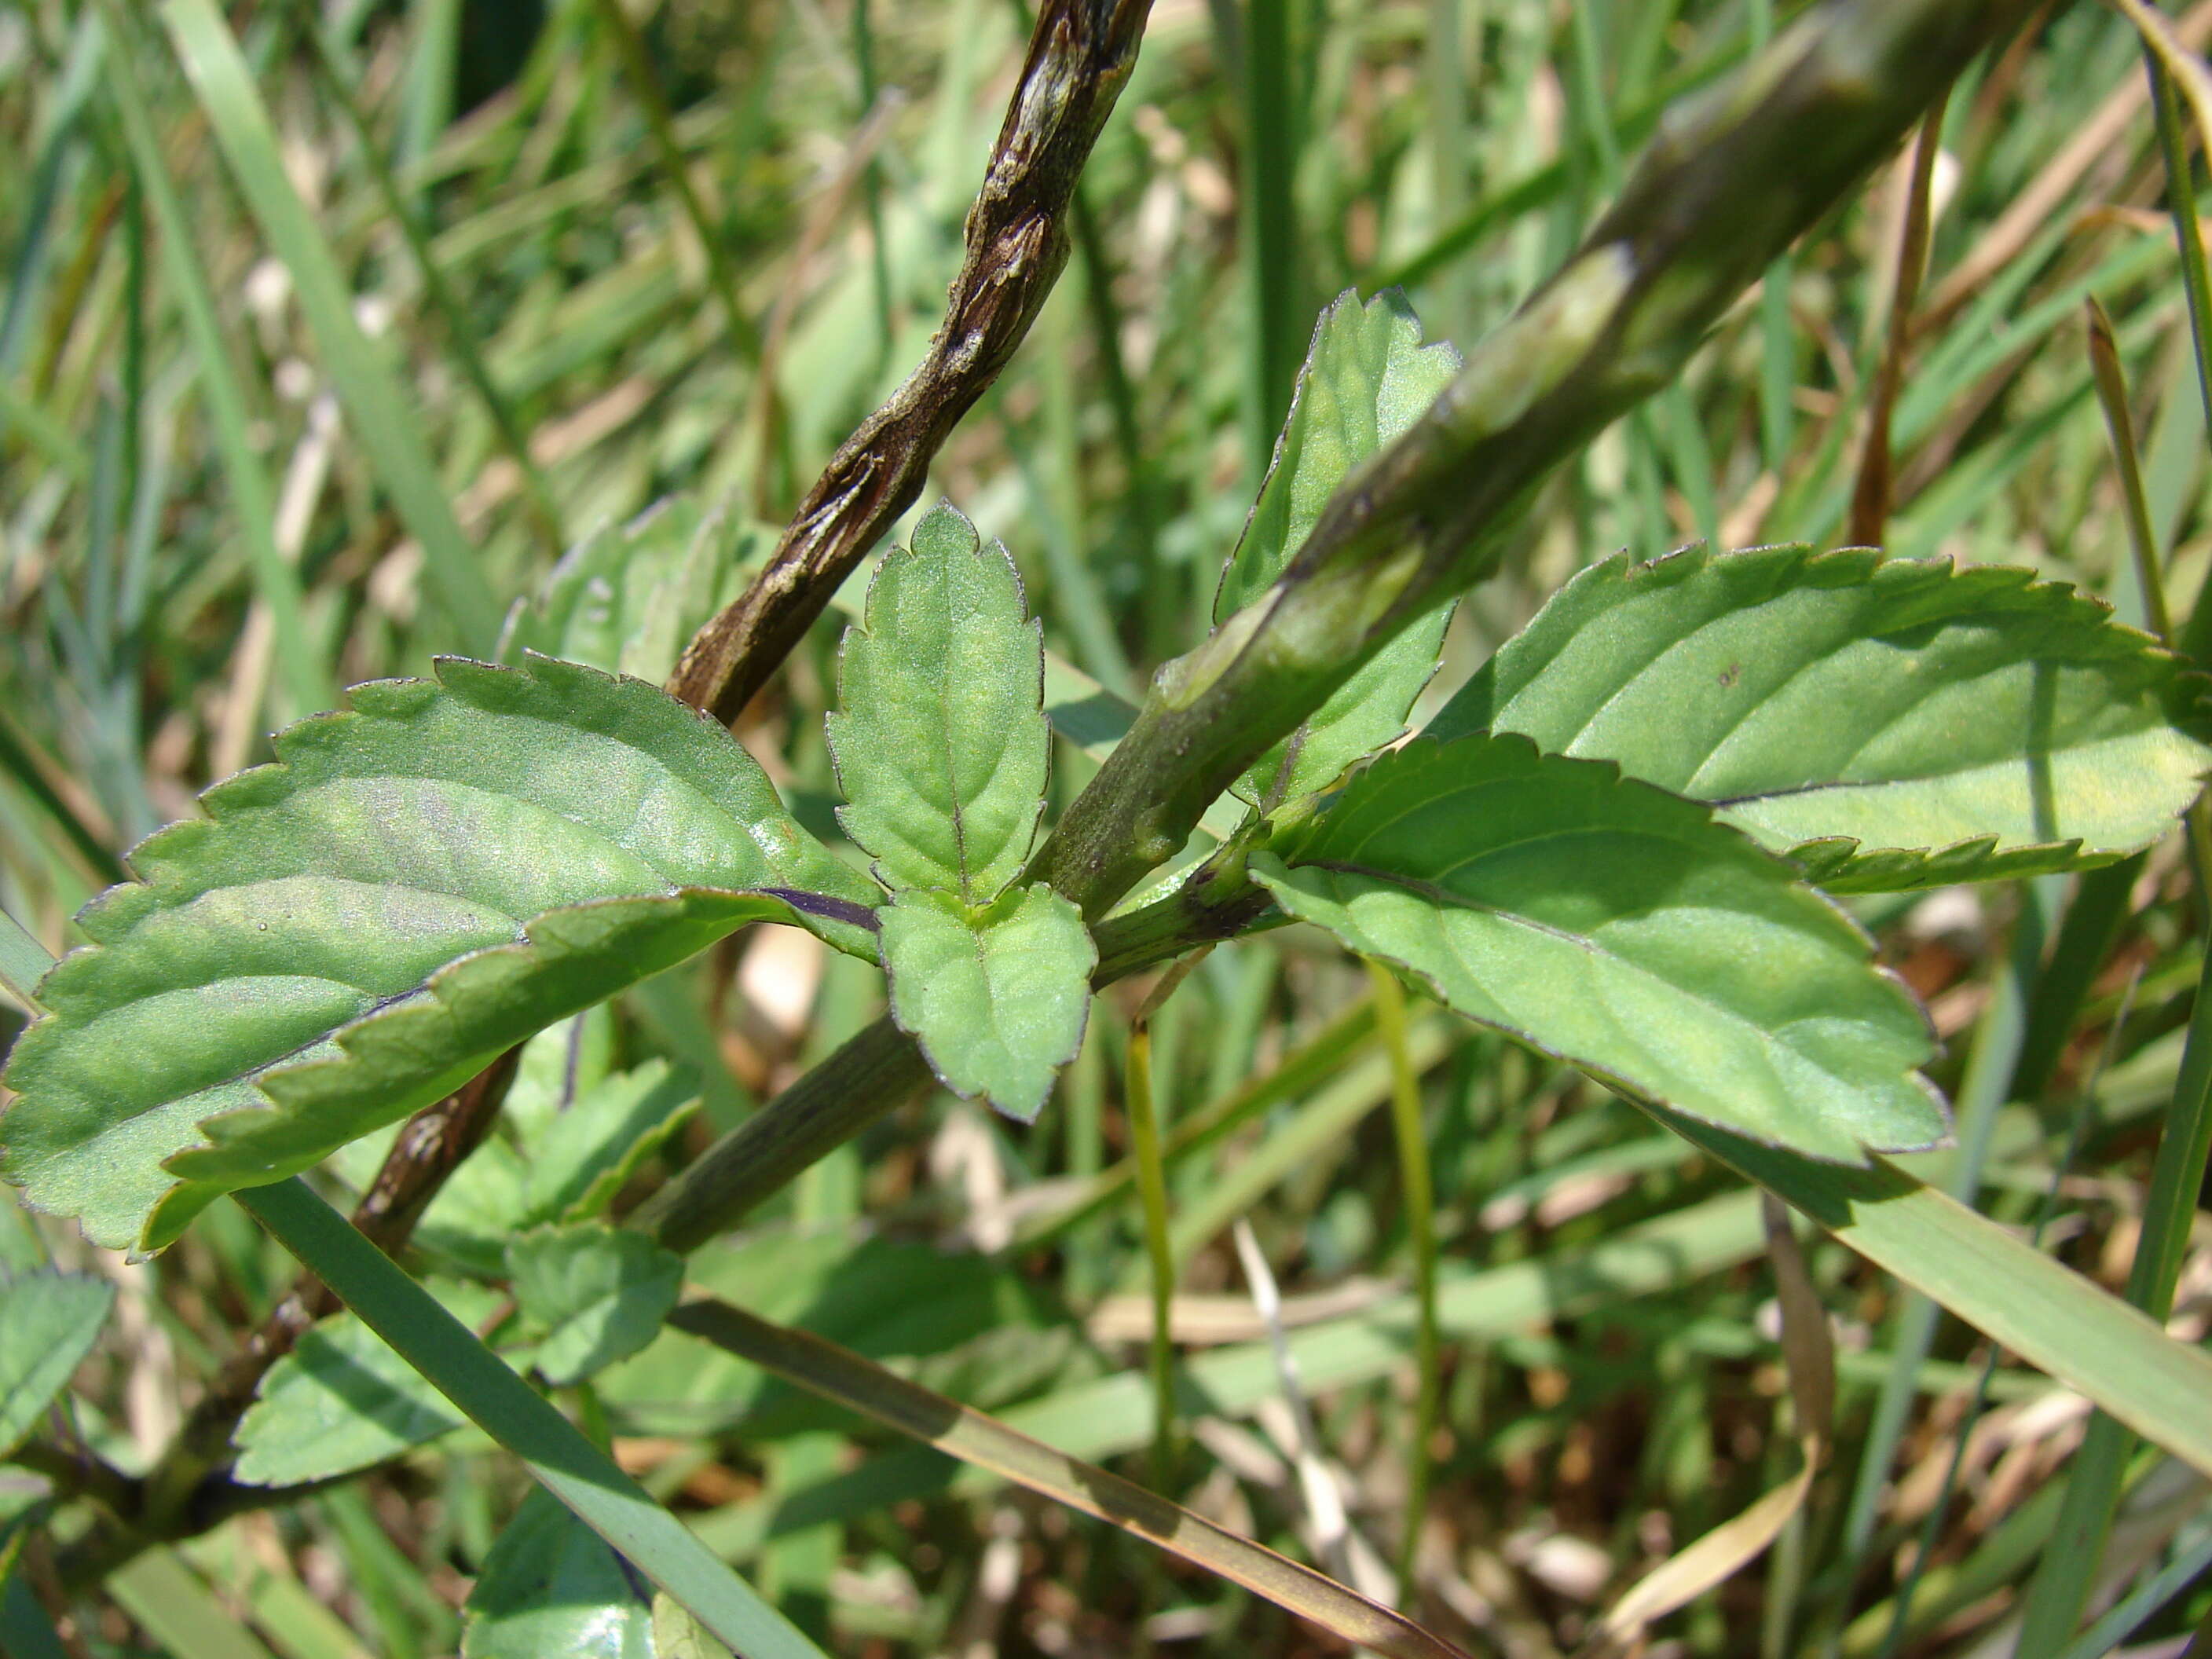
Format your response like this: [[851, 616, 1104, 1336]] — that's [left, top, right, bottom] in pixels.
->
[[1584, 1195, 1836, 1659]]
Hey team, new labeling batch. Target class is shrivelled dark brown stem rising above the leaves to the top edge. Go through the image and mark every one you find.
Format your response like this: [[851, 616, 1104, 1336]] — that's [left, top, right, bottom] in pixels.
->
[[668, 0, 1152, 723]]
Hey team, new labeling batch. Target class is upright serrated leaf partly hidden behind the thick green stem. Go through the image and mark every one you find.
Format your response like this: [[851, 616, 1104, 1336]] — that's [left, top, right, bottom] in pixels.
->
[[1214, 290, 1460, 803]]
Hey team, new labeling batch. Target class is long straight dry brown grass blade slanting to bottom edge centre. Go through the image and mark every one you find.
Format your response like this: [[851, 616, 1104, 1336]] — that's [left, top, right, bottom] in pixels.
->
[[668, 1301, 1467, 1659]]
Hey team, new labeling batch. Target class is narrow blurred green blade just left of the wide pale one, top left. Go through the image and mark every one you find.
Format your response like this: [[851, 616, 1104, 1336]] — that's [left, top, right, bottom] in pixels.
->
[[106, 6, 339, 715]]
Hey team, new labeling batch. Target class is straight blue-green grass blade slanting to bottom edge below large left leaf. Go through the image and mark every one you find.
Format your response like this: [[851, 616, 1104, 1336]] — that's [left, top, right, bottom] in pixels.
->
[[239, 1179, 823, 1659]]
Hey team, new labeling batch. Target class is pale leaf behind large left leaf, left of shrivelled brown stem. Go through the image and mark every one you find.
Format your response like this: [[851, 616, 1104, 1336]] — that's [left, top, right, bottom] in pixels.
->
[[500, 506, 772, 683]]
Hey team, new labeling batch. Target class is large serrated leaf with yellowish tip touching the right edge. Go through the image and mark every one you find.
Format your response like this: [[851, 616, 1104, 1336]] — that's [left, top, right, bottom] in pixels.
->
[[1429, 547, 2212, 892]]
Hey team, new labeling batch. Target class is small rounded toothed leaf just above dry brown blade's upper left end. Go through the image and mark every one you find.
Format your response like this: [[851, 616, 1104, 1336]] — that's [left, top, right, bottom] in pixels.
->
[[507, 1223, 683, 1385]]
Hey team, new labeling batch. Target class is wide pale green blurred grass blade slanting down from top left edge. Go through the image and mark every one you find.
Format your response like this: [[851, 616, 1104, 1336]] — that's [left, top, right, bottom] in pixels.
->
[[162, 0, 502, 657]]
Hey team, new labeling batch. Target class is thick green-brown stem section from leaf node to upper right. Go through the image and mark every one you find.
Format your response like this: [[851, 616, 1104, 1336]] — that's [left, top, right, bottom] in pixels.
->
[[1028, 0, 2031, 916]]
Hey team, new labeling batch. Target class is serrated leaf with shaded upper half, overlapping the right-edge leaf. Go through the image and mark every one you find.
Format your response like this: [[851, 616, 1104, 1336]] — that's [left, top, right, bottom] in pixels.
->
[[1252, 737, 1944, 1163]]
